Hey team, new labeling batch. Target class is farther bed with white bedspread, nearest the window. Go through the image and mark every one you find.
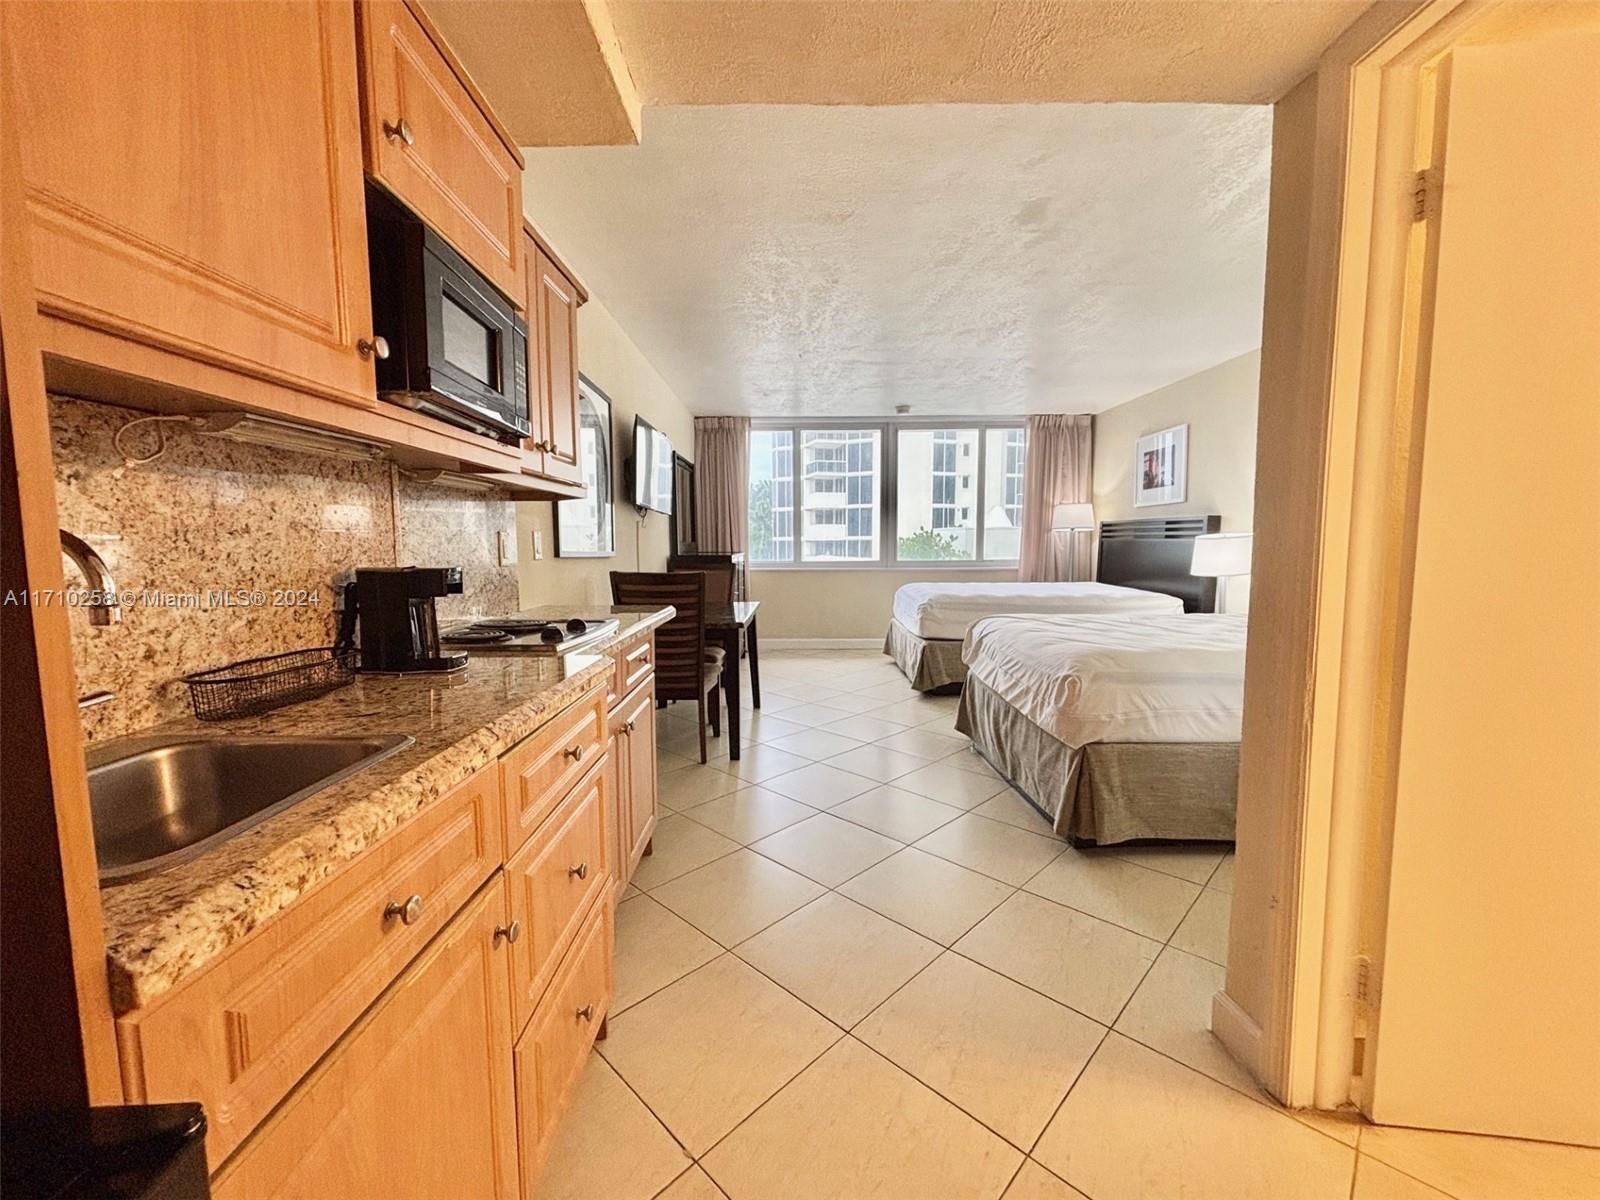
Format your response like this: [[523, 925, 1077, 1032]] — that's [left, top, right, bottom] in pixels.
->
[[883, 579, 1184, 691]]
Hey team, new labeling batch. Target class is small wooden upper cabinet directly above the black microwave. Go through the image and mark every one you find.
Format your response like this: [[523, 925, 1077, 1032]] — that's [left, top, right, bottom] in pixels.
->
[[357, 0, 523, 304]]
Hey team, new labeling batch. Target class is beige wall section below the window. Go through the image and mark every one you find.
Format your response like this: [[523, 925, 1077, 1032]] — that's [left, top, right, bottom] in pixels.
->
[[750, 566, 1016, 642]]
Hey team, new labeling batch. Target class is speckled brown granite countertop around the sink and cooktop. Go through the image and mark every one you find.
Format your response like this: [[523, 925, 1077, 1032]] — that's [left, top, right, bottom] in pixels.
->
[[101, 606, 672, 1014]]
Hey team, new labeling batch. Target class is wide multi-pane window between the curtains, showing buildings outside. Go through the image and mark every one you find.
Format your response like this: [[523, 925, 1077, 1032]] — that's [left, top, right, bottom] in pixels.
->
[[749, 421, 1026, 566]]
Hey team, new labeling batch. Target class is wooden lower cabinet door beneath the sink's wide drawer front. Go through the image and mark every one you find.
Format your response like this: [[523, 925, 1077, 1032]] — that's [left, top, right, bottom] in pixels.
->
[[213, 875, 517, 1200]]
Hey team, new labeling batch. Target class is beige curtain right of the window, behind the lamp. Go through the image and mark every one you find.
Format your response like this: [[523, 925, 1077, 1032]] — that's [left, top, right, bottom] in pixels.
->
[[1016, 413, 1094, 582]]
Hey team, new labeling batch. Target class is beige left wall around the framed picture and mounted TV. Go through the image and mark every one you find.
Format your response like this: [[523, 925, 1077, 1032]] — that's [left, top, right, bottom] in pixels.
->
[[517, 299, 694, 606]]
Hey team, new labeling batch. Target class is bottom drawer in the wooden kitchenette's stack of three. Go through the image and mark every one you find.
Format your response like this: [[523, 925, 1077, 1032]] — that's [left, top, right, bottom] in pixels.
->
[[515, 894, 613, 1195]]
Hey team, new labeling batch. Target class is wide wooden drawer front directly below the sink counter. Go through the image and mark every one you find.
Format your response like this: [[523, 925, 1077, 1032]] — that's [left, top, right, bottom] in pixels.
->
[[117, 765, 502, 1162]]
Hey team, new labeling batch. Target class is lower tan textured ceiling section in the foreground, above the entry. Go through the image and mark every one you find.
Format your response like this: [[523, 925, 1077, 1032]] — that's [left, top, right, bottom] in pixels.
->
[[604, 0, 1368, 104]]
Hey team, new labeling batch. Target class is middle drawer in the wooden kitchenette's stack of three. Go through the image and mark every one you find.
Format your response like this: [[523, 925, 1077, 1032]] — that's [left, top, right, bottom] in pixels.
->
[[506, 762, 610, 1030]]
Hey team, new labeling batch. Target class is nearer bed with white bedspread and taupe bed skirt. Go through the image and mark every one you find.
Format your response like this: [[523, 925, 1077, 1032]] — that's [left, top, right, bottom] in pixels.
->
[[957, 613, 1245, 845]]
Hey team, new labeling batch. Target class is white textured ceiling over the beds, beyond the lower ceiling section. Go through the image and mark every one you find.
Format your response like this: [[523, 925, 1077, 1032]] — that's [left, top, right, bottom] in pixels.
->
[[525, 104, 1272, 416]]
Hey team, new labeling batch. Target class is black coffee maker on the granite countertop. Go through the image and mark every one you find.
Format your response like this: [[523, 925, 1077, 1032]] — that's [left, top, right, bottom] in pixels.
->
[[338, 566, 467, 670]]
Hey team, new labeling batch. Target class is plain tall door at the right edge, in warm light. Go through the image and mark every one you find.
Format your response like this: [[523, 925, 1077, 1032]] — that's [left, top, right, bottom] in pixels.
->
[[1363, 5, 1600, 1144]]
